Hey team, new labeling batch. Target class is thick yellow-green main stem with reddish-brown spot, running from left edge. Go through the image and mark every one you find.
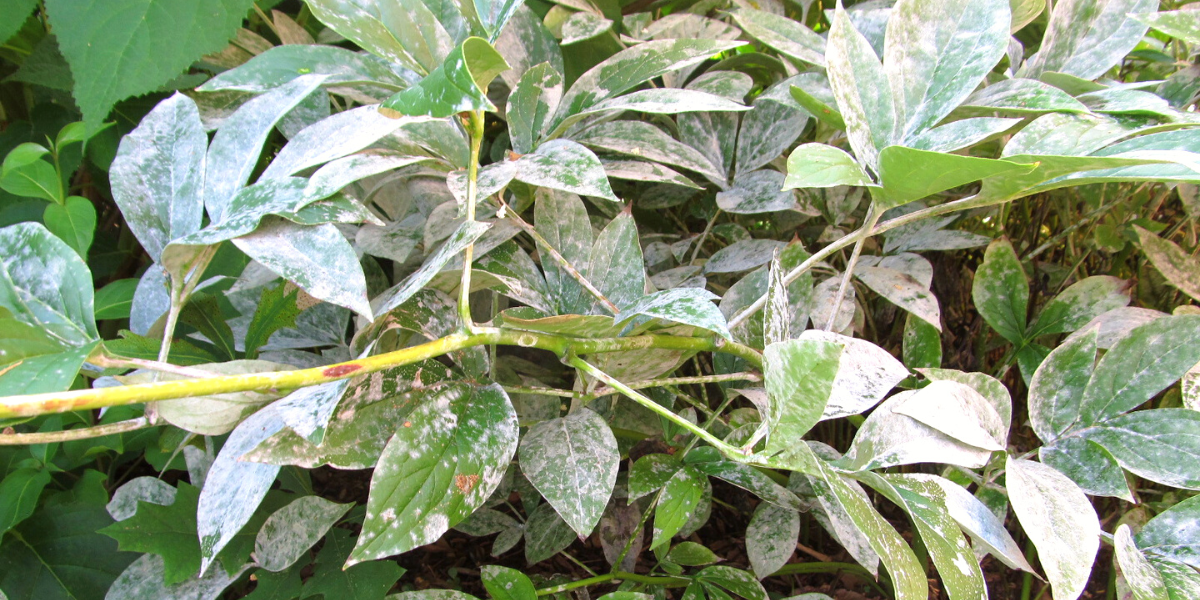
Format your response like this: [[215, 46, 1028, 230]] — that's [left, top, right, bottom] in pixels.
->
[[0, 328, 762, 425]]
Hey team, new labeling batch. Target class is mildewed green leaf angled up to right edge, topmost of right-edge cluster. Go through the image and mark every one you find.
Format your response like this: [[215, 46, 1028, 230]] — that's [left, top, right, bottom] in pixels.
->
[[1080, 314, 1200, 425]]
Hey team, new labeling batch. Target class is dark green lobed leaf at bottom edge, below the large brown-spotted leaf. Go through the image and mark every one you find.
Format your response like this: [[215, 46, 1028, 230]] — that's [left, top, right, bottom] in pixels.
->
[[300, 528, 404, 599]]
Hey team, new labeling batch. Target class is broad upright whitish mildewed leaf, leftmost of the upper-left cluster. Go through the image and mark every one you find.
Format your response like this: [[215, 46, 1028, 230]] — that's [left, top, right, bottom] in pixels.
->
[[109, 94, 209, 262]]
